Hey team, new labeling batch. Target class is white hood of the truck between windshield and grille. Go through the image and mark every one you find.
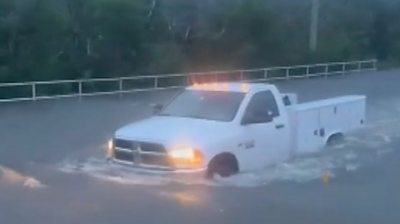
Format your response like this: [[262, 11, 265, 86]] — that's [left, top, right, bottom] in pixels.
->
[[115, 116, 234, 146]]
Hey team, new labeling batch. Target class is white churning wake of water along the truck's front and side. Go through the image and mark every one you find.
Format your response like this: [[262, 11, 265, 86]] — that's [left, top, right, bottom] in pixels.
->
[[59, 103, 400, 187]]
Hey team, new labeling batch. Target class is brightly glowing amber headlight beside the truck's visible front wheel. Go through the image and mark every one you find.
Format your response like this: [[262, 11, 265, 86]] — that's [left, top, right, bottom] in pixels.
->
[[168, 148, 203, 169]]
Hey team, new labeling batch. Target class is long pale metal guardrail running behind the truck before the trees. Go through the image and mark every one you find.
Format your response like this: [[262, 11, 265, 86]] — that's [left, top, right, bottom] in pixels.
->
[[0, 59, 377, 102]]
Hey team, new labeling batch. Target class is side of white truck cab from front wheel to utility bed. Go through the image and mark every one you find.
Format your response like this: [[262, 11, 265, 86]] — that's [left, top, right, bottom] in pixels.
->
[[223, 84, 290, 171]]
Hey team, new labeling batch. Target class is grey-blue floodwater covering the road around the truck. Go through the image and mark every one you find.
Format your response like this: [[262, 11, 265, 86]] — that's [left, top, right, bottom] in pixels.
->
[[0, 70, 400, 224]]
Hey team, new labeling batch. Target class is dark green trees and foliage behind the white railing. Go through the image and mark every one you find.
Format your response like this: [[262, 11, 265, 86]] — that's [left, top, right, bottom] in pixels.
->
[[0, 0, 400, 82]]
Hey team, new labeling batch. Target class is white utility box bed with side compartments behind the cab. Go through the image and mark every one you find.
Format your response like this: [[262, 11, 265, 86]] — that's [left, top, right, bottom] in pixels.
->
[[288, 96, 366, 154]]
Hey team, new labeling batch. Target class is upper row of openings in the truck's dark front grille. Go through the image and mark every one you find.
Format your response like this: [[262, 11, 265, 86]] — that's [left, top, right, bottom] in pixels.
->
[[114, 139, 166, 153]]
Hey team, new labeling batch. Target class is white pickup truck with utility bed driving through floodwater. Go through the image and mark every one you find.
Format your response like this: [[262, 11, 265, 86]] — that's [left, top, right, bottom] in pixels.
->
[[107, 83, 366, 177]]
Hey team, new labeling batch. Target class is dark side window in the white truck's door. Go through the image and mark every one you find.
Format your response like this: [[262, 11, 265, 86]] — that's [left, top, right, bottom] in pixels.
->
[[245, 91, 279, 123]]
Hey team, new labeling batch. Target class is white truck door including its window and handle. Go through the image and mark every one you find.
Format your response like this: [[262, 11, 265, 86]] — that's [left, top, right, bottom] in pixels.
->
[[238, 91, 289, 169]]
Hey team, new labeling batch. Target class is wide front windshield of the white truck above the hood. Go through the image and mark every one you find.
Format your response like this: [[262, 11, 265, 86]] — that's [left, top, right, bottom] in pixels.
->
[[159, 90, 245, 121]]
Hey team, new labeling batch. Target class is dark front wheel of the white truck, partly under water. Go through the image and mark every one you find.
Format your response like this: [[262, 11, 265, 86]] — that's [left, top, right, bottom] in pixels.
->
[[206, 153, 239, 179]]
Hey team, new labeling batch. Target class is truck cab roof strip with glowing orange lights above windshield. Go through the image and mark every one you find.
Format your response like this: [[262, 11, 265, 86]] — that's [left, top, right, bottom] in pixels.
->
[[186, 82, 273, 93]]
